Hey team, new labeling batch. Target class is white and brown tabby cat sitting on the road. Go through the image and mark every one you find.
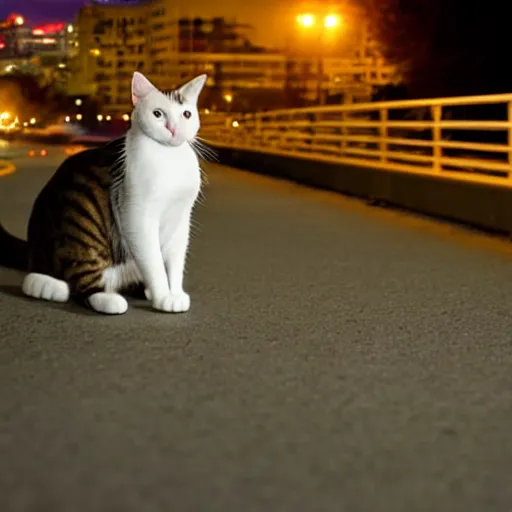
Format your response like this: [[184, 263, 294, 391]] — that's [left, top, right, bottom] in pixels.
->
[[0, 72, 207, 315]]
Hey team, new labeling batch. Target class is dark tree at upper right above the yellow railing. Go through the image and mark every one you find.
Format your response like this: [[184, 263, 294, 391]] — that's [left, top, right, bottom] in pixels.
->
[[363, 0, 512, 96]]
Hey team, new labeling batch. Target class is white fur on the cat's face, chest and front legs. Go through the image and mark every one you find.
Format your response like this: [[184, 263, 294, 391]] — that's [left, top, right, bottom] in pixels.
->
[[117, 73, 205, 312]]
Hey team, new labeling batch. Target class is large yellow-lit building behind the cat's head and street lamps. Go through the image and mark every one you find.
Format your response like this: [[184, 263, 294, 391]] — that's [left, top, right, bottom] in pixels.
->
[[71, 0, 393, 114]]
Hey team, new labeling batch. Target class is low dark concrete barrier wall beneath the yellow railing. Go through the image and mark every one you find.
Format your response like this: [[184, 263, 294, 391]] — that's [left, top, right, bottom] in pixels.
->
[[216, 149, 512, 234]]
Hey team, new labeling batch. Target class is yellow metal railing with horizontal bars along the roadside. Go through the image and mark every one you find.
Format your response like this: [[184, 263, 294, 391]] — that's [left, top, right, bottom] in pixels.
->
[[201, 94, 512, 186]]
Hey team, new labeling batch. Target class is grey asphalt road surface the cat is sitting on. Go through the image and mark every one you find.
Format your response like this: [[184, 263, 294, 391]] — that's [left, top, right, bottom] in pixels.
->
[[0, 141, 512, 512]]
